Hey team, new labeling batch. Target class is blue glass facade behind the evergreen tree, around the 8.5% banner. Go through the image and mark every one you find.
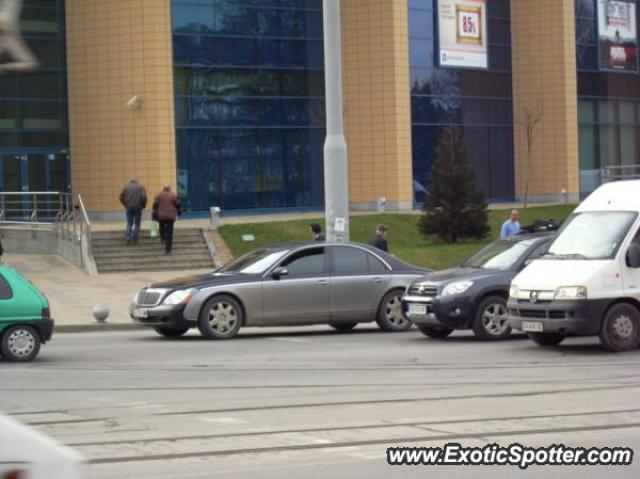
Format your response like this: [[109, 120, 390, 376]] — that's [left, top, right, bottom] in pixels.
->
[[409, 0, 514, 201]]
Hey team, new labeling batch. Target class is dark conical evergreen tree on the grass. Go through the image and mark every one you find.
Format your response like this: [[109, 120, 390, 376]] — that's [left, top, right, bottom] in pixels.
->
[[418, 126, 489, 243]]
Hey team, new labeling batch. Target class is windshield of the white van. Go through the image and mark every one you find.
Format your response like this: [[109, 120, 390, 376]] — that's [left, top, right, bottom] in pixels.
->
[[545, 211, 638, 259]]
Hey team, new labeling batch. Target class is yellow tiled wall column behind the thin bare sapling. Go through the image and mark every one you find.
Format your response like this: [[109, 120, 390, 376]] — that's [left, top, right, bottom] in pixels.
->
[[511, 0, 579, 199]]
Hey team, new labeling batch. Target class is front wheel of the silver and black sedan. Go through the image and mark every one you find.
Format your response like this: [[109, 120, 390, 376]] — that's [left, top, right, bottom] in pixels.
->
[[198, 294, 244, 339]]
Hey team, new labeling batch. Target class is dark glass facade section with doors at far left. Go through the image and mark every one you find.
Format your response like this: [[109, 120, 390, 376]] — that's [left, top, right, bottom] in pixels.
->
[[0, 0, 70, 195]]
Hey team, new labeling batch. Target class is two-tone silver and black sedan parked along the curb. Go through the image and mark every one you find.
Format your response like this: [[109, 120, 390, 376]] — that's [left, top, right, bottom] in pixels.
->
[[129, 242, 429, 339]]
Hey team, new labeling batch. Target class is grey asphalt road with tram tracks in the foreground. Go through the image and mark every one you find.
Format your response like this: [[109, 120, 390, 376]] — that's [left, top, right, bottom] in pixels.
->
[[0, 325, 640, 479]]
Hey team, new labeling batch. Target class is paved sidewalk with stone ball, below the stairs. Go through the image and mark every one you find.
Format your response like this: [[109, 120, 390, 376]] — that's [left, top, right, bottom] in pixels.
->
[[3, 254, 211, 332]]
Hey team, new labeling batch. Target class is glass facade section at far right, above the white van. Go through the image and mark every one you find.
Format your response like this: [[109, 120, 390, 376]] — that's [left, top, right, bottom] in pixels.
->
[[575, 0, 640, 196]]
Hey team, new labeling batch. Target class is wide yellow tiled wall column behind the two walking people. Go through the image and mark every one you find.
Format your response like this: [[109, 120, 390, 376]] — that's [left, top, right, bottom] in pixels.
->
[[66, 0, 176, 212]]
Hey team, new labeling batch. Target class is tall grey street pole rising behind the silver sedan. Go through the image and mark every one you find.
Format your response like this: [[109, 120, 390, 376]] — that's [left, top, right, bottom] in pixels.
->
[[322, 0, 349, 241]]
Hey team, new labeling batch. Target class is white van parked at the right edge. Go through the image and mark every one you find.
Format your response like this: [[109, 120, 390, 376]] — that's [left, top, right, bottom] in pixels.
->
[[507, 180, 640, 351]]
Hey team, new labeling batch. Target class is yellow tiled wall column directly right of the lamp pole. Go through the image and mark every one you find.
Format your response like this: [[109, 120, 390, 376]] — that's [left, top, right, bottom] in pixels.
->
[[341, 0, 413, 207]]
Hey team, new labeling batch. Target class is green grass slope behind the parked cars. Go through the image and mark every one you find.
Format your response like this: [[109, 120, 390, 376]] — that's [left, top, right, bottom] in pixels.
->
[[219, 205, 576, 269]]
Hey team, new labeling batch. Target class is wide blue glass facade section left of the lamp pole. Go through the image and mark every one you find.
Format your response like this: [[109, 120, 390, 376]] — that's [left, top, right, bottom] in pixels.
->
[[172, 0, 325, 209]]
